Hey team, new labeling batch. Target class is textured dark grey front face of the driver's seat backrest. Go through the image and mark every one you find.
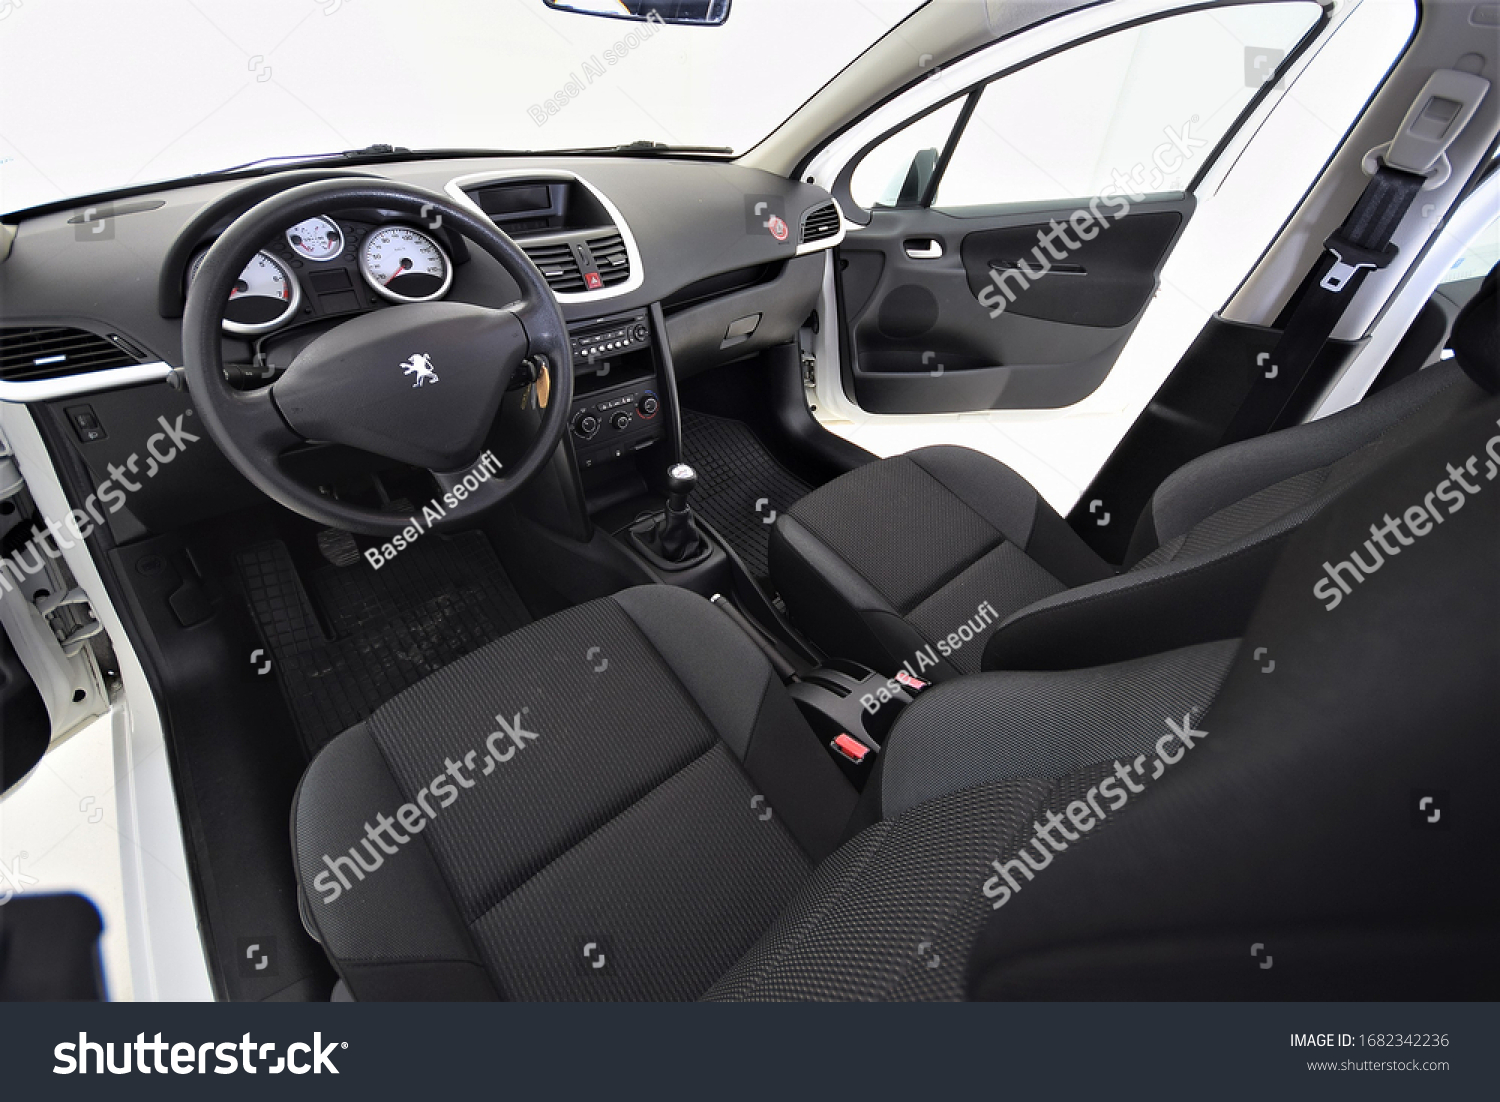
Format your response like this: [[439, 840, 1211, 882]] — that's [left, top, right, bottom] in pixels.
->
[[707, 640, 1239, 1002]]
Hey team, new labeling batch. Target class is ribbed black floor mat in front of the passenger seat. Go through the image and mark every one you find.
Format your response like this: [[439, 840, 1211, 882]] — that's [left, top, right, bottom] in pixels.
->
[[683, 409, 813, 579]]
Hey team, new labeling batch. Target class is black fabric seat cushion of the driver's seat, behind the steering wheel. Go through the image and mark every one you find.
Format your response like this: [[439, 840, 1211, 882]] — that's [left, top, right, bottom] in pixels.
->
[[293, 586, 855, 1000]]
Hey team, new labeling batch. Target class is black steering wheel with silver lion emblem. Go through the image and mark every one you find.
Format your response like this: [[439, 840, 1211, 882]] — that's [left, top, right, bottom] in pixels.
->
[[183, 180, 573, 537]]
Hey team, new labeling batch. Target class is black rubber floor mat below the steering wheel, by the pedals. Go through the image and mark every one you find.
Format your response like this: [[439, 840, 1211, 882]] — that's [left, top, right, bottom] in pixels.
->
[[239, 532, 531, 754]]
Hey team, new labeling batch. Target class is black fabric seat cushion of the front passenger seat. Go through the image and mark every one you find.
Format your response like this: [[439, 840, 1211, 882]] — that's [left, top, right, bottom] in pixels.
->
[[771, 447, 1110, 681]]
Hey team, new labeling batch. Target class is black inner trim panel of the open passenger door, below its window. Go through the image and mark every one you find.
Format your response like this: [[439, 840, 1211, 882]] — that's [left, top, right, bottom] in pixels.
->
[[840, 193, 1194, 414]]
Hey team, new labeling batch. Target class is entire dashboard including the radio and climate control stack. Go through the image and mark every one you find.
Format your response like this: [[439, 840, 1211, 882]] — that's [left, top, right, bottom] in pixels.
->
[[0, 156, 845, 540]]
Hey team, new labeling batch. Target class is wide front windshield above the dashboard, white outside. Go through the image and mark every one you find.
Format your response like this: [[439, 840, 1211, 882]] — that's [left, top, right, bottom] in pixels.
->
[[0, 0, 923, 211]]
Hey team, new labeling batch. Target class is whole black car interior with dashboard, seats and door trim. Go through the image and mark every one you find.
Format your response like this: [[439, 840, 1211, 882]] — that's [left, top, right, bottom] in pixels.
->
[[0, 3, 1500, 1002]]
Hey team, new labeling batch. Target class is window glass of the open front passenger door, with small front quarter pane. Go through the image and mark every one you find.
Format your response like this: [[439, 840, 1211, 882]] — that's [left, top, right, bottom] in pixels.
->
[[851, 0, 1322, 208]]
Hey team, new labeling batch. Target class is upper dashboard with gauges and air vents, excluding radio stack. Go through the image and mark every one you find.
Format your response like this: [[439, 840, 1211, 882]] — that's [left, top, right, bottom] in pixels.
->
[[0, 157, 845, 402]]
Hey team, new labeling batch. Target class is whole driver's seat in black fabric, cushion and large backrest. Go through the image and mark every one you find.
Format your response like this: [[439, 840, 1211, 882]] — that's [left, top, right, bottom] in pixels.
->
[[293, 269, 1500, 1000]]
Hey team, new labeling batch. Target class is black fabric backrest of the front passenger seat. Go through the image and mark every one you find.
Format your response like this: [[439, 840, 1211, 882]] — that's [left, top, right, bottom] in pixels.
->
[[983, 265, 1500, 670]]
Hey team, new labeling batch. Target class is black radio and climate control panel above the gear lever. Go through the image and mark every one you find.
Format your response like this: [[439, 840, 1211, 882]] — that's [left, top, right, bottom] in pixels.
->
[[569, 310, 666, 469]]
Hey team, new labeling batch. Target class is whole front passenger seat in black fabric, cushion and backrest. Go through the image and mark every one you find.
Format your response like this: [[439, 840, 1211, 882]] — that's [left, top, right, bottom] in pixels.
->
[[770, 266, 1496, 681]]
